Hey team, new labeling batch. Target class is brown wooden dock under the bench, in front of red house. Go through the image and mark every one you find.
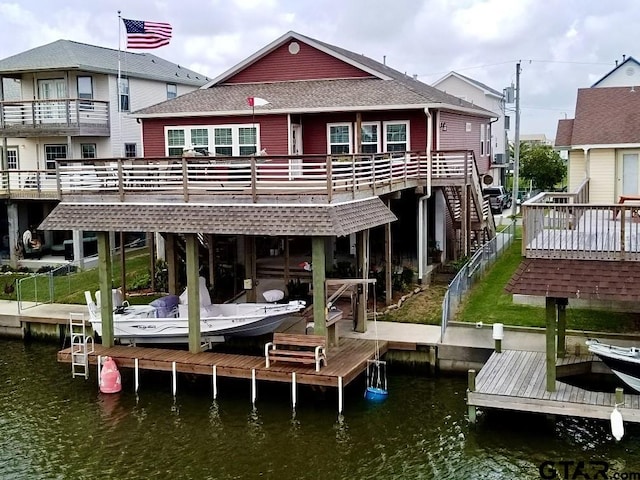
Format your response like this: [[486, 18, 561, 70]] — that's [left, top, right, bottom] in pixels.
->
[[58, 338, 388, 388]]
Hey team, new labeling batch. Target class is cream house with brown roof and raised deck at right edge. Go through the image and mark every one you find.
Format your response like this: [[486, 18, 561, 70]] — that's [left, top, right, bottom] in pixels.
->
[[507, 57, 640, 387]]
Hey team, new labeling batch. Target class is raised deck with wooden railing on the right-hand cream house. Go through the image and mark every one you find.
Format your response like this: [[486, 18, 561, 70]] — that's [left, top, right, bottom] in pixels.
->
[[522, 181, 640, 261]]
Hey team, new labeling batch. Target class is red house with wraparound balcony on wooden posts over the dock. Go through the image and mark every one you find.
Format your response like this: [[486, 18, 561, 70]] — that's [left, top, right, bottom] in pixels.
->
[[42, 32, 496, 351]]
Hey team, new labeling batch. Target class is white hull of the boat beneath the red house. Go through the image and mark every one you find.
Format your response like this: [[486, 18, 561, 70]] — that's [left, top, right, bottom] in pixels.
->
[[91, 302, 305, 344]]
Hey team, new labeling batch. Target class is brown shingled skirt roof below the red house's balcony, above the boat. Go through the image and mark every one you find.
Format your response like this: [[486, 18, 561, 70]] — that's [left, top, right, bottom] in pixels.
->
[[38, 197, 396, 236]]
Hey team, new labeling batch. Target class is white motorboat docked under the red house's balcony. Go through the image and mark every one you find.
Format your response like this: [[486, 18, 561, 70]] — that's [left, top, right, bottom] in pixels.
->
[[85, 279, 306, 345]]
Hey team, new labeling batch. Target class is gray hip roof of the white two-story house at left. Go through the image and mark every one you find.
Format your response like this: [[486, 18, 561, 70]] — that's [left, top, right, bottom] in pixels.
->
[[0, 40, 209, 86]]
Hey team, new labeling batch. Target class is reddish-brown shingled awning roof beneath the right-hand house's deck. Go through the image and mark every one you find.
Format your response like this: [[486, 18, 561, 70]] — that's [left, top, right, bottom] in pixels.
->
[[505, 258, 640, 302]]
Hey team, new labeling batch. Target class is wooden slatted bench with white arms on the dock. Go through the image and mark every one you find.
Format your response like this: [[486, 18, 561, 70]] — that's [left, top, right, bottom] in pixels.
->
[[264, 332, 327, 372]]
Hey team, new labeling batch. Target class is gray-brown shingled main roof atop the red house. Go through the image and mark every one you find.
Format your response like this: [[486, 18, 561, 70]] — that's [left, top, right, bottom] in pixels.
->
[[135, 32, 498, 118]]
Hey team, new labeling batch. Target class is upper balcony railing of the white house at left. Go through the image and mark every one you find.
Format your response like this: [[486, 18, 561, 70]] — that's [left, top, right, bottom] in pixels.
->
[[0, 98, 109, 134]]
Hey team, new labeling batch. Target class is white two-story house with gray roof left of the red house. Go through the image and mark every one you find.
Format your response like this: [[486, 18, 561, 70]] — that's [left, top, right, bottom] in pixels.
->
[[0, 40, 209, 263]]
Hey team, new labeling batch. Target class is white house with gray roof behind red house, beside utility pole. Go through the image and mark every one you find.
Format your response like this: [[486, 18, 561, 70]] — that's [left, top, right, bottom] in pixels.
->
[[433, 72, 509, 185]]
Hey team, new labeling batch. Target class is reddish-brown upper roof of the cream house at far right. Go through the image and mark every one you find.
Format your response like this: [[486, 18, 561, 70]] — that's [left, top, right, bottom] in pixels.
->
[[556, 87, 640, 147]]
